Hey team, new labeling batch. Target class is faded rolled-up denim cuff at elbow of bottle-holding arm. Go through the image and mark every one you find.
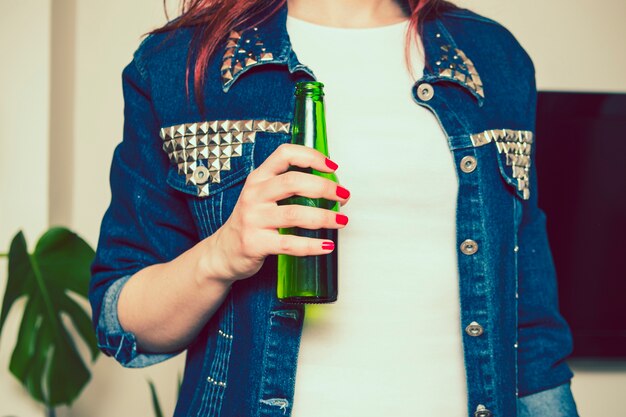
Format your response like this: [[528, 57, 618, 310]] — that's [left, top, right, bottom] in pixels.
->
[[96, 275, 181, 368]]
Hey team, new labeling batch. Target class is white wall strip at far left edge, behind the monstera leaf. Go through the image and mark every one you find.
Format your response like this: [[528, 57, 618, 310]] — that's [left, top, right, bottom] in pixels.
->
[[0, 0, 51, 416]]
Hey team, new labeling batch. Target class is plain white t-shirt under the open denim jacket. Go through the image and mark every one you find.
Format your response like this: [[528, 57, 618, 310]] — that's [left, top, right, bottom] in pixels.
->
[[287, 17, 467, 417]]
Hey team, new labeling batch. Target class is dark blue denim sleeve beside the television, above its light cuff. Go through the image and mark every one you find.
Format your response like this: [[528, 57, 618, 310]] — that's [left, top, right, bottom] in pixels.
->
[[518, 59, 572, 396]]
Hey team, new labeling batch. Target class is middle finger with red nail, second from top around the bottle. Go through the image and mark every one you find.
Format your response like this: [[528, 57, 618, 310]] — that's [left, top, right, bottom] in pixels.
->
[[255, 171, 350, 205]]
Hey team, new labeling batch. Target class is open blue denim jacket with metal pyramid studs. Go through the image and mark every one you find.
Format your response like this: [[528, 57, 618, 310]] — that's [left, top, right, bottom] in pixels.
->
[[90, 6, 572, 417]]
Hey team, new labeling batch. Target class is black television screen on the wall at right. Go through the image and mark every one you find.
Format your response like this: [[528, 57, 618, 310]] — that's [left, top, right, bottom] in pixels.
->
[[535, 92, 626, 358]]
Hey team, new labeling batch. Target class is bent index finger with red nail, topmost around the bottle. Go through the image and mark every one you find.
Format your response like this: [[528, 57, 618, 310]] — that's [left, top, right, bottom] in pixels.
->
[[250, 143, 337, 181]]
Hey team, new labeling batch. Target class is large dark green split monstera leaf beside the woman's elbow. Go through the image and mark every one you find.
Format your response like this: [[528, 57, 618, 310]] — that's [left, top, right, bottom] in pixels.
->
[[0, 227, 98, 407]]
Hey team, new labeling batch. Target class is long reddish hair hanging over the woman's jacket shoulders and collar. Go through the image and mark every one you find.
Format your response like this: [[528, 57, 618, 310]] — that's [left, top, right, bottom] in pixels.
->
[[151, 0, 454, 103]]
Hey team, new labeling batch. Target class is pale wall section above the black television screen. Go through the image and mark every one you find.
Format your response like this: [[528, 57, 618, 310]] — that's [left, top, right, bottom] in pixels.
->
[[456, 0, 626, 92]]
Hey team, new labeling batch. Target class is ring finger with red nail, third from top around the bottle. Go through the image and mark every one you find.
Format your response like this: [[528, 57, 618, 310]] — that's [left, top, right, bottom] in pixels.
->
[[261, 204, 348, 230]]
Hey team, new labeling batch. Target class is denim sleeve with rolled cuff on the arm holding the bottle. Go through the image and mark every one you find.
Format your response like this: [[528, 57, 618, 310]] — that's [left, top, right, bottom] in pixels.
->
[[89, 49, 199, 367]]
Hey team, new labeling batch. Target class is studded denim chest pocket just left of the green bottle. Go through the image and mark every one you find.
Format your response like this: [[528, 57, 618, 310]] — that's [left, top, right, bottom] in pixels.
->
[[161, 119, 290, 237]]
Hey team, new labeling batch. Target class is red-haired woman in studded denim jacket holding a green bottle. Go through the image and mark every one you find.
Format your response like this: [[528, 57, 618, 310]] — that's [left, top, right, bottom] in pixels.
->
[[91, 0, 577, 417]]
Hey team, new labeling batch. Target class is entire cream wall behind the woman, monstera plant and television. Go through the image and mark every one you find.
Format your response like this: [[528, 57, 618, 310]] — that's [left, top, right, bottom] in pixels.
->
[[0, 0, 626, 417]]
